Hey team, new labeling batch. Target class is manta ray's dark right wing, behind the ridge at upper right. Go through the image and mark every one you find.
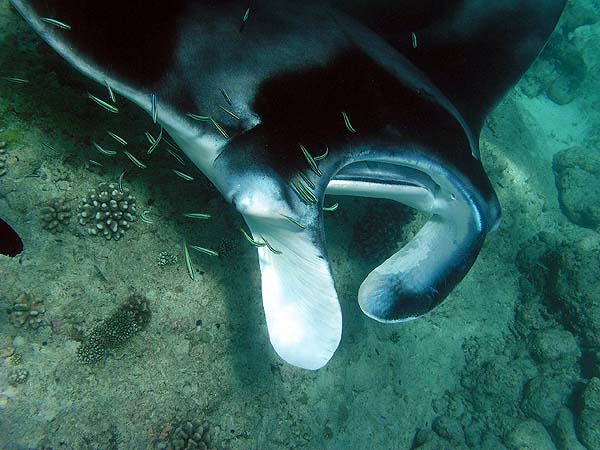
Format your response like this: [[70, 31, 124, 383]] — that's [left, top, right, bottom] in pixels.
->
[[333, 0, 566, 133]]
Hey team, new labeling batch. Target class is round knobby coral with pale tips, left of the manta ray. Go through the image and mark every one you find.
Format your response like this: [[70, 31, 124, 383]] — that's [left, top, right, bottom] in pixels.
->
[[78, 183, 136, 241]]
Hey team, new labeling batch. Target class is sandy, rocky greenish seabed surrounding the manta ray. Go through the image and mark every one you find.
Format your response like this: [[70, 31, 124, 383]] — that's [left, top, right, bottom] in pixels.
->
[[0, 0, 600, 450]]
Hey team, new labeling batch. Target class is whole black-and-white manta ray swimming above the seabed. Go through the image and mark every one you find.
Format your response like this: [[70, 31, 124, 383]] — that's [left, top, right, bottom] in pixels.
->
[[11, 0, 564, 370]]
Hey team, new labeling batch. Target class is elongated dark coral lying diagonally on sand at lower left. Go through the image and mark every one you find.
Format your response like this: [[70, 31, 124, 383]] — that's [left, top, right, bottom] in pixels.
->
[[77, 294, 151, 364]]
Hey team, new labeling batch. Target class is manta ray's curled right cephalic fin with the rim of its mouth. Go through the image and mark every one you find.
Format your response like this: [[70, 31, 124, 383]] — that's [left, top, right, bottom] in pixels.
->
[[327, 132, 500, 322]]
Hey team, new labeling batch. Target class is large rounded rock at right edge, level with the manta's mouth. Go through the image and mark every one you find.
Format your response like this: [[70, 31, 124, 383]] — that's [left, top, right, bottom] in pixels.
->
[[552, 147, 600, 229]]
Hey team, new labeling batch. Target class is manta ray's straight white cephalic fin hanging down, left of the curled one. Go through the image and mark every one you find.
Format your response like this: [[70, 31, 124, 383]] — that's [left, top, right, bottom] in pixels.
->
[[244, 216, 342, 370]]
